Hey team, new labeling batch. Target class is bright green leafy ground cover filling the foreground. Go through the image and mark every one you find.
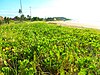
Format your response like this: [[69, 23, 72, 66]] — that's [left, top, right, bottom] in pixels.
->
[[0, 22, 100, 75]]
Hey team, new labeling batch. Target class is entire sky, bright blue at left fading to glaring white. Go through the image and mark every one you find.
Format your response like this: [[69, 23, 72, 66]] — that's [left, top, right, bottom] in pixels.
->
[[0, 0, 100, 21]]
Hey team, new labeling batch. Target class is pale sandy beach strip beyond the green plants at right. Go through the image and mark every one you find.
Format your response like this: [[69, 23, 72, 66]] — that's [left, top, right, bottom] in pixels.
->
[[47, 21, 100, 29]]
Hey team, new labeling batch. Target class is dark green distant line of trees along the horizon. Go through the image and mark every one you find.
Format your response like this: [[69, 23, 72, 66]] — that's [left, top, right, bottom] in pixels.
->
[[0, 14, 71, 25]]
